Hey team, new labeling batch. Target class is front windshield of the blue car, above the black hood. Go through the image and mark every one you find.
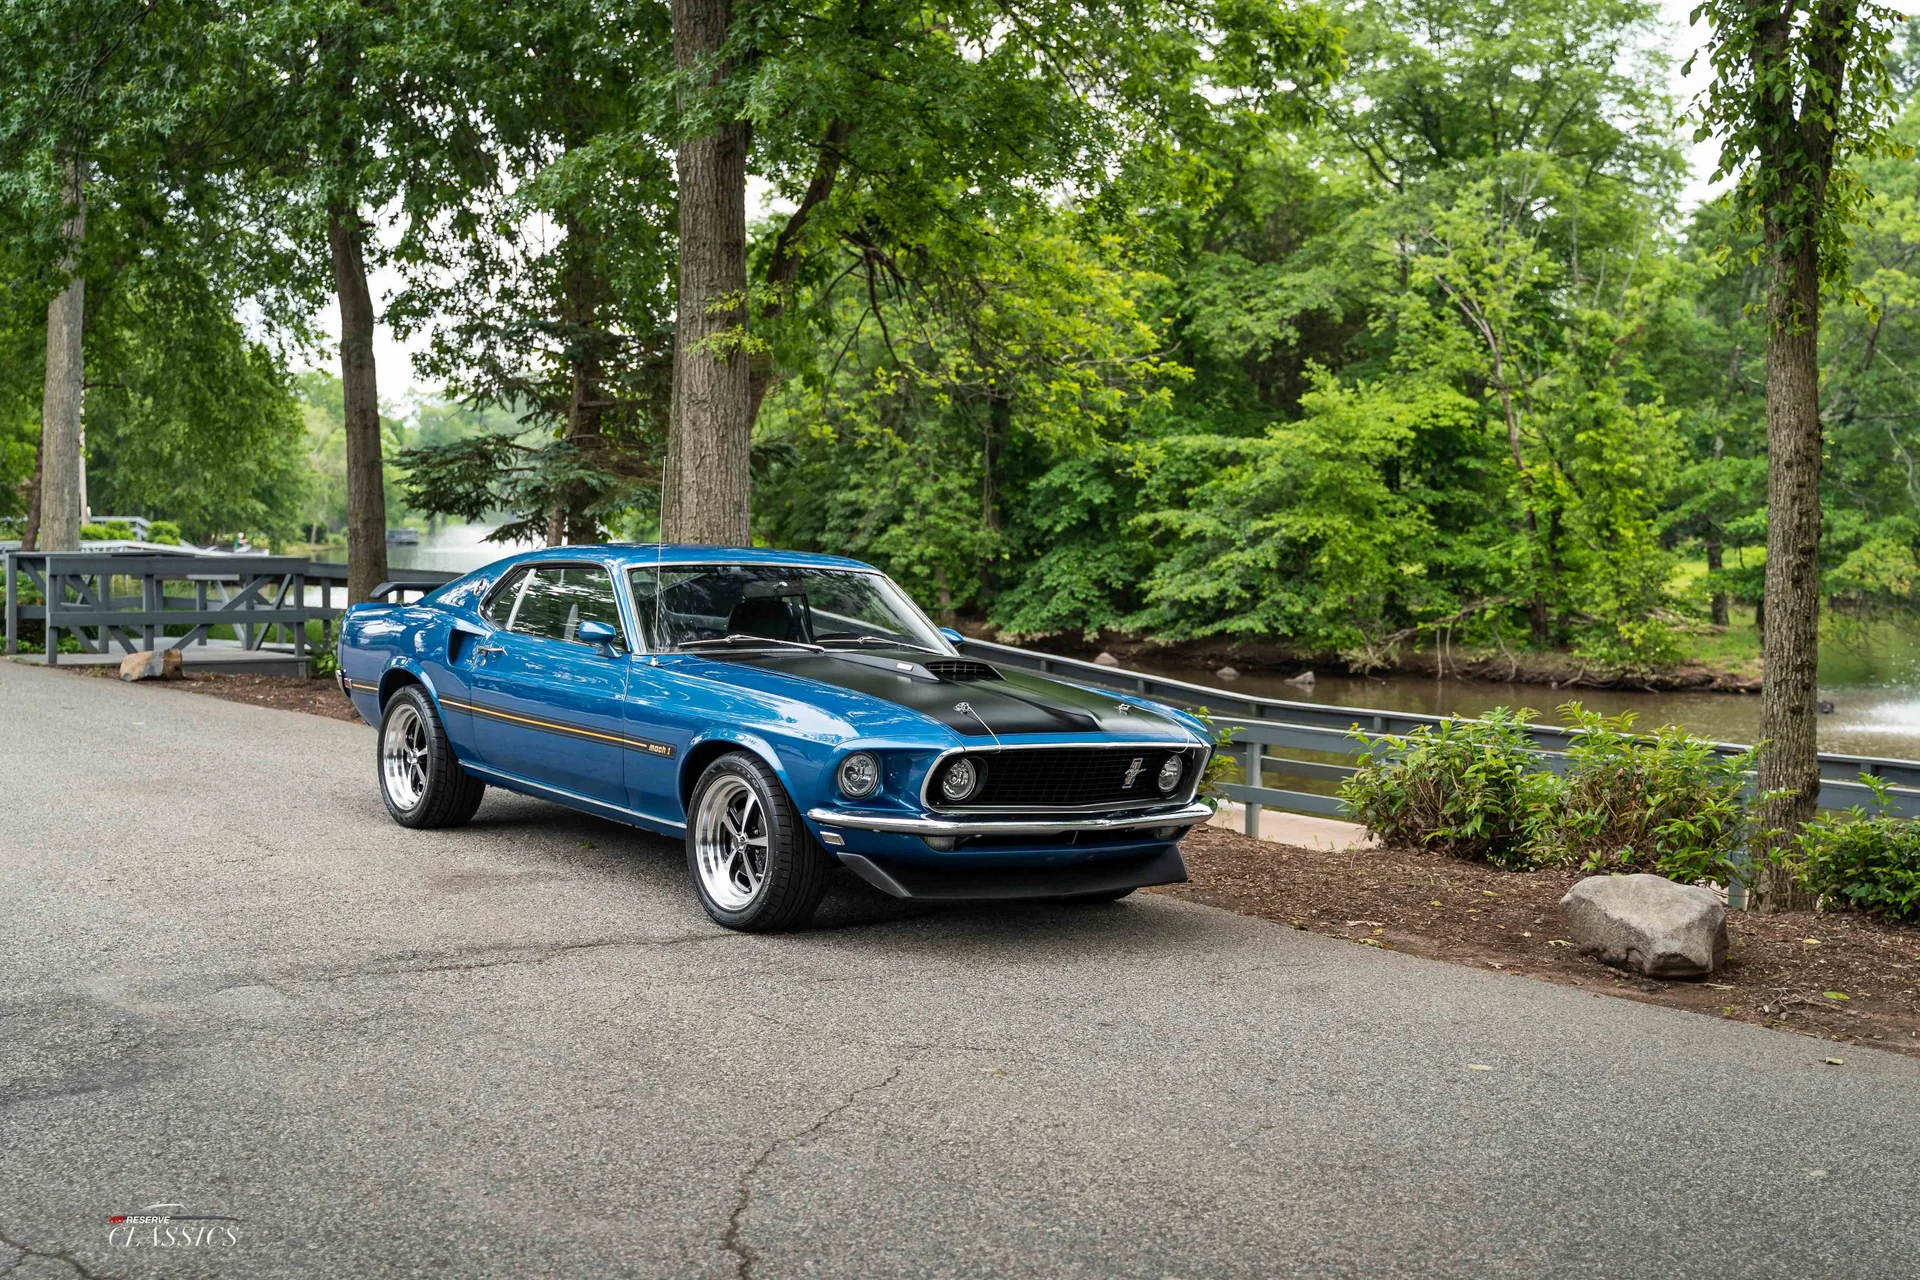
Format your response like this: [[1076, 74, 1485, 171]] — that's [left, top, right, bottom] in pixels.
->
[[632, 564, 954, 654]]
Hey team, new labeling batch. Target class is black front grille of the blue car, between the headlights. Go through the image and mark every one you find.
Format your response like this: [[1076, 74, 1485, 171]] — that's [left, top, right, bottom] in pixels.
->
[[927, 747, 1198, 808]]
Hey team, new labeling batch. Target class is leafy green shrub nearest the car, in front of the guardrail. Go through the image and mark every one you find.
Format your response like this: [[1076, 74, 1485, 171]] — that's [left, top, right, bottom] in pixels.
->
[[1340, 706, 1559, 867]]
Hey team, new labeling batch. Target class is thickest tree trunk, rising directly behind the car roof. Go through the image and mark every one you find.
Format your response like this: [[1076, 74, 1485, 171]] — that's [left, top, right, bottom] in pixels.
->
[[660, 0, 753, 547]]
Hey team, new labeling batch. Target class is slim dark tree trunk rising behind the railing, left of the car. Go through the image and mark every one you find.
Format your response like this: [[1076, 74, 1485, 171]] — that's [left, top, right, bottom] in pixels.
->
[[326, 205, 386, 603]]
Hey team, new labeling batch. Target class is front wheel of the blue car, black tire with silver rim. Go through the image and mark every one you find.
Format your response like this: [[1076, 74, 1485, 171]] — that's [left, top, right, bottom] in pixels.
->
[[687, 750, 831, 933]]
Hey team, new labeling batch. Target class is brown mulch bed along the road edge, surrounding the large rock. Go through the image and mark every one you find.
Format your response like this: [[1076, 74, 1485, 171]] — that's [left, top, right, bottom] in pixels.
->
[[1156, 827, 1920, 1057]]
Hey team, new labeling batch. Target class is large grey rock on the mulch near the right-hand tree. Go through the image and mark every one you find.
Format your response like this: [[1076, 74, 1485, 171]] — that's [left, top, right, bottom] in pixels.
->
[[1561, 875, 1726, 979]]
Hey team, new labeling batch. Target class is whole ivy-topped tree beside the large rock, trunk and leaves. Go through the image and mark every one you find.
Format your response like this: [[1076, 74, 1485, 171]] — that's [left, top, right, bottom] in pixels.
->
[[1695, 0, 1905, 910]]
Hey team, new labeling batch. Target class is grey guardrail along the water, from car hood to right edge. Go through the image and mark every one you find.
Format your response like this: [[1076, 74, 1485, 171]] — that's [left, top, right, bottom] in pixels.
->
[[960, 639, 1920, 835]]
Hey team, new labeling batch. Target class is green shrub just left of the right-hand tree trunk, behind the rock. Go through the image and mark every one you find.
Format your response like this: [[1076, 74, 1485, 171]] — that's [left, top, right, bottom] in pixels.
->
[[1532, 702, 1755, 885]]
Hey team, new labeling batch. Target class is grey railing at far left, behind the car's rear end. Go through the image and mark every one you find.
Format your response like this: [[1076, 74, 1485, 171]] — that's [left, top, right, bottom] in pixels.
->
[[6, 551, 455, 666]]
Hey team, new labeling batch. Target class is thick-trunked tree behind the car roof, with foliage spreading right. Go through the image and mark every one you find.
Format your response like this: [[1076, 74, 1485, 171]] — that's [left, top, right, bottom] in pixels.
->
[[664, 0, 1336, 539]]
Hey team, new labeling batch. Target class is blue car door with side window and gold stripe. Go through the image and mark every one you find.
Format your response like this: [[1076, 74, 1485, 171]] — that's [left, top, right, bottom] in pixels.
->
[[468, 564, 630, 808]]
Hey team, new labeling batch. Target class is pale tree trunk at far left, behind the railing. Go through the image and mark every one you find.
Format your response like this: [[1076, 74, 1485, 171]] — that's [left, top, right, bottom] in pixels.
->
[[35, 157, 86, 551]]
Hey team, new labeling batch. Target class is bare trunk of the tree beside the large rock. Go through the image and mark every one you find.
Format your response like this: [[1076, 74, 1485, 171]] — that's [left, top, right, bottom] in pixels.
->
[[1759, 236, 1820, 912]]
